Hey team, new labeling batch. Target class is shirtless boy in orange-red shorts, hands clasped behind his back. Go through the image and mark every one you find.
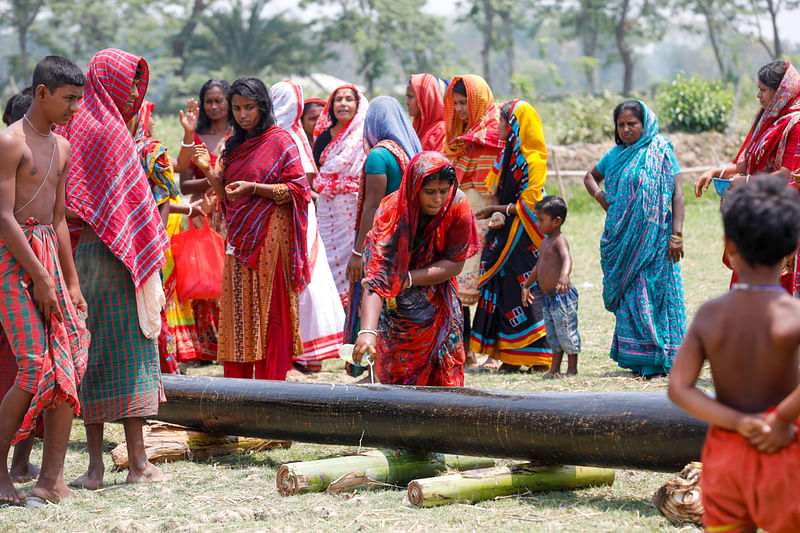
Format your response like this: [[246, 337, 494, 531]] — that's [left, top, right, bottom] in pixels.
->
[[669, 177, 800, 533]]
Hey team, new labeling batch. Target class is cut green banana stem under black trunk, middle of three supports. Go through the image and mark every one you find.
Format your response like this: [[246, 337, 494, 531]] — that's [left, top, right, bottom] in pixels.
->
[[275, 450, 495, 496]]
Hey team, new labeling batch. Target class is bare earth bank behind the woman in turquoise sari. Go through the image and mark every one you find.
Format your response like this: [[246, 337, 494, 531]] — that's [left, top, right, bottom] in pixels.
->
[[547, 132, 743, 172]]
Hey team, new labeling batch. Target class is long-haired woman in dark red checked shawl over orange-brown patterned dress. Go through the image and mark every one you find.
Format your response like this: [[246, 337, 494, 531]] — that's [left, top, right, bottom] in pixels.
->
[[194, 78, 311, 380]]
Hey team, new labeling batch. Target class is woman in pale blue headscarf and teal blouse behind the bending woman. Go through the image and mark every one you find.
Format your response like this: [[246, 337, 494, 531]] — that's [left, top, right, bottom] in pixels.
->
[[344, 96, 422, 342]]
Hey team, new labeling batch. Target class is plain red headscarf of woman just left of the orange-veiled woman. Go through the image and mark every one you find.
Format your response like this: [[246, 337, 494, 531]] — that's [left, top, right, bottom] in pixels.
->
[[409, 74, 447, 152]]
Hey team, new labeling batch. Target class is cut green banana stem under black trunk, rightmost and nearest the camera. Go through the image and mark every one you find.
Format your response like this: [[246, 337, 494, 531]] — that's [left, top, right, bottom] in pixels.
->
[[408, 463, 614, 507]]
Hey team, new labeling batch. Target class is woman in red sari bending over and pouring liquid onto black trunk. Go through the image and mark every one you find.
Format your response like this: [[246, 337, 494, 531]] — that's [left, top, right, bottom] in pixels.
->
[[353, 152, 478, 387]]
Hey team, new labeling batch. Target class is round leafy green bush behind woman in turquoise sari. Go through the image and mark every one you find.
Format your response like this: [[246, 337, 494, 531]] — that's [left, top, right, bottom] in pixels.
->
[[657, 72, 733, 133]]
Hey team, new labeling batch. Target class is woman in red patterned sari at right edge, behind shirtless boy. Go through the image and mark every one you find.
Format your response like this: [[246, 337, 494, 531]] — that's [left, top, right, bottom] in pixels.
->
[[694, 61, 800, 294]]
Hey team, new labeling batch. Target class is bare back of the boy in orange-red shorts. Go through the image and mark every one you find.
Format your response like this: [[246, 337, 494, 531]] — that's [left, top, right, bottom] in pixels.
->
[[685, 287, 800, 413]]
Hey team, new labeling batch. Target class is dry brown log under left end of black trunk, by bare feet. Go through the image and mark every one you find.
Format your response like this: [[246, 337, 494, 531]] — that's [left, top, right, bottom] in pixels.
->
[[111, 422, 292, 470]]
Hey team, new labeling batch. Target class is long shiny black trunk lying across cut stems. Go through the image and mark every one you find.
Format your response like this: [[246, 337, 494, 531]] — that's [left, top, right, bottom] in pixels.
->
[[154, 375, 707, 471]]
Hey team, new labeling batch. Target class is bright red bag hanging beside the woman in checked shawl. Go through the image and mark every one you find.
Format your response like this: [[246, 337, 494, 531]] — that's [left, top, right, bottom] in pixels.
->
[[170, 218, 225, 302]]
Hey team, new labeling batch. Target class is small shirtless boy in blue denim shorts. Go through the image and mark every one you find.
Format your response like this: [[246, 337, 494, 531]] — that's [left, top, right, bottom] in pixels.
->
[[522, 196, 581, 379]]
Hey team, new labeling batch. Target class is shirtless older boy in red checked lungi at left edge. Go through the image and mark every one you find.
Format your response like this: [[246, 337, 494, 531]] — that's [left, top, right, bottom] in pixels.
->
[[0, 56, 89, 504]]
